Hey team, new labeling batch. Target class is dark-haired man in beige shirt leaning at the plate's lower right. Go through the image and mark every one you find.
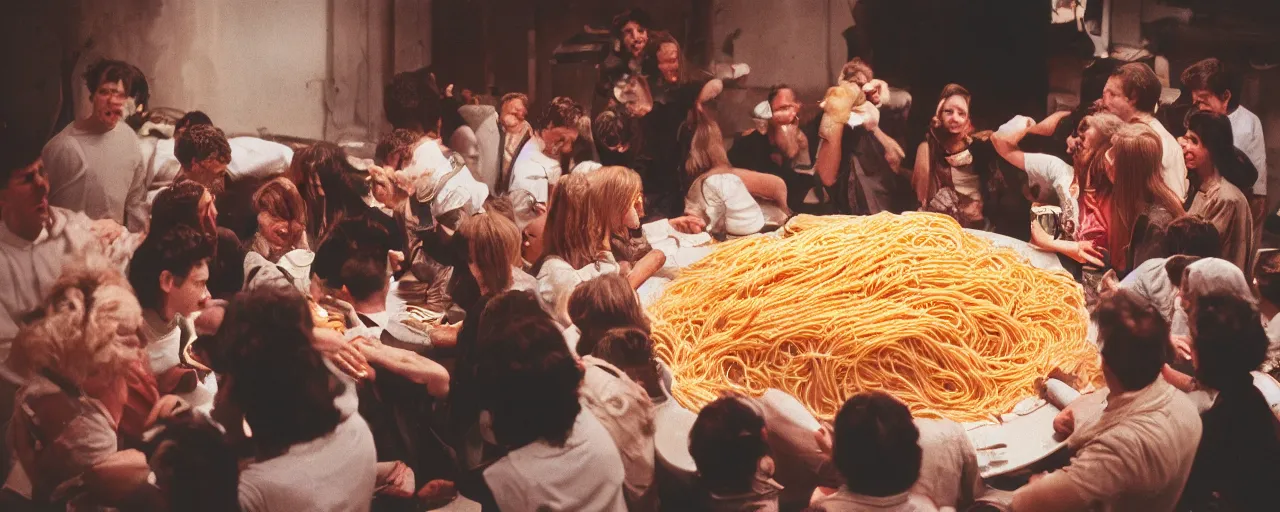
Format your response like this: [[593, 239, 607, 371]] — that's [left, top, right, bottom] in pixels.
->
[[1012, 291, 1202, 511]]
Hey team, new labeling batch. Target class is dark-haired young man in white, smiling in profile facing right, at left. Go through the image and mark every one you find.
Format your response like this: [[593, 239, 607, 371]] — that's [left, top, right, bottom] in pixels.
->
[[129, 225, 218, 410]]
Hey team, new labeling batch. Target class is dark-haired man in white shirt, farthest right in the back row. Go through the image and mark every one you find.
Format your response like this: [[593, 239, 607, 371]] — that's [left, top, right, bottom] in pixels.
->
[[1181, 59, 1267, 217]]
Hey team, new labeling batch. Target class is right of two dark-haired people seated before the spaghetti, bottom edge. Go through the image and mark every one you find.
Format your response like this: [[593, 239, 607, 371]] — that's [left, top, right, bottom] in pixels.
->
[[813, 392, 937, 512]]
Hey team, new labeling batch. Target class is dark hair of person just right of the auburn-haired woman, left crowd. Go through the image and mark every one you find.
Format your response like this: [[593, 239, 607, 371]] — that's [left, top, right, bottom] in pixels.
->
[[311, 216, 392, 301]]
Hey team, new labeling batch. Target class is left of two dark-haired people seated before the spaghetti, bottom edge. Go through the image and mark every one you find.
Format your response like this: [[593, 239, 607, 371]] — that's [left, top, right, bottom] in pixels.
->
[[689, 396, 782, 512]]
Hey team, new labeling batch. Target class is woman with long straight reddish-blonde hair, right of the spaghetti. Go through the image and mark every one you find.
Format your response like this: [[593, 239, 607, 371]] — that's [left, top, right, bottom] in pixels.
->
[[1103, 124, 1185, 274]]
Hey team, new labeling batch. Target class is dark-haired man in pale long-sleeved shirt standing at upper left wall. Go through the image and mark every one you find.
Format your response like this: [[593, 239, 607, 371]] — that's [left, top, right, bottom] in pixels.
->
[[44, 60, 147, 232]]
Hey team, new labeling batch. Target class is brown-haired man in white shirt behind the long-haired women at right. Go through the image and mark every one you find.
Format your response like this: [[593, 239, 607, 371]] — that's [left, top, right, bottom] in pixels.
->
[[1102, 63, 1188, 198]]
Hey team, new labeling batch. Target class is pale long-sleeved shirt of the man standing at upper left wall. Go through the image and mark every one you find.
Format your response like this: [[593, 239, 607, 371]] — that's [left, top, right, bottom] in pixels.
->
[[42, 123, 150, 232]]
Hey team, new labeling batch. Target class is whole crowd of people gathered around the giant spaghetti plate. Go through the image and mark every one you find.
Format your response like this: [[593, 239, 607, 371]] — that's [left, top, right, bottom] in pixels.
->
[[0, 10, 1280, 512]]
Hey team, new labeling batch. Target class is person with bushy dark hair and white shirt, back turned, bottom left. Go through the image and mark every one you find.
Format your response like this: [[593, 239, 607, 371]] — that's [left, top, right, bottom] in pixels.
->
[[210, 288, 378, 512]]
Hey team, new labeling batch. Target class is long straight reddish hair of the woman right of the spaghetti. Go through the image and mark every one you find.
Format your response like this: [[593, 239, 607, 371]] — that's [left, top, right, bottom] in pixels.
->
[[1110, 123, 1184, 270]]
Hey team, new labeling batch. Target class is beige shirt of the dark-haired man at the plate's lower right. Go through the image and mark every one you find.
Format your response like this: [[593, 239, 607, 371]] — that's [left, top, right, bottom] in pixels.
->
[[1061, 378, 1201, 511]]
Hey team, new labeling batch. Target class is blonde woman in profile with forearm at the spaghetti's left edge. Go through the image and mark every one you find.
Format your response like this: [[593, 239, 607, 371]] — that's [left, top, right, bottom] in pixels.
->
[[588, 166, 667, 288]]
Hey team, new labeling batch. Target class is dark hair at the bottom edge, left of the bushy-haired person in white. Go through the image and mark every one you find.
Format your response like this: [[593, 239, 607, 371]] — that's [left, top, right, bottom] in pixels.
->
[[146, 415, 239, 512]]
